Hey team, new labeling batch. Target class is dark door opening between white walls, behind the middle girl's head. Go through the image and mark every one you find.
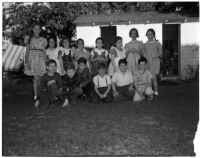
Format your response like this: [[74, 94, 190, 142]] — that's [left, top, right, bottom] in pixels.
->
[[101, 26, 117, 50]]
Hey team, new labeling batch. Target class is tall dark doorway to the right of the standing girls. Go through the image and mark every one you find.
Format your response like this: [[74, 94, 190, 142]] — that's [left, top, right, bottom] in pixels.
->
[[161, 24, 180, 77]]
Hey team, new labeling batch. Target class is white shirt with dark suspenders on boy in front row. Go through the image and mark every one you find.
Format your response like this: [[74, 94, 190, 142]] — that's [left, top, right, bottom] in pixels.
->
[[93, 75, 111, 88]]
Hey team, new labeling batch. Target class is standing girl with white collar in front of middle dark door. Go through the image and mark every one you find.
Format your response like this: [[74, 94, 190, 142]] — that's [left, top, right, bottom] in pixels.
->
[[91, 37, 108, 75]]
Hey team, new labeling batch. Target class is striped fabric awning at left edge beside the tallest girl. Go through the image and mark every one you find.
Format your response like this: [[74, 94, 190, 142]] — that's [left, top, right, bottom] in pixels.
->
[[2, 44, 26, 71]]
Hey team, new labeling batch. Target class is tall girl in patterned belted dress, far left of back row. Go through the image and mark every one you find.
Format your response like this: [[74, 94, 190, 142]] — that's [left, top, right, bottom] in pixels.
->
[[25, 24, 47, 99]]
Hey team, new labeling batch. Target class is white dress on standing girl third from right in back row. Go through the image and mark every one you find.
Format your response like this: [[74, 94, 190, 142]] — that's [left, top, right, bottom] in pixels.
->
[[108, 46, 126, 76]]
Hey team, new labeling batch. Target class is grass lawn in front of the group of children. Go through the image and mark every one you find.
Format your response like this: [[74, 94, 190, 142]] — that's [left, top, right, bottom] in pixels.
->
[[2, 81, 199, 156]]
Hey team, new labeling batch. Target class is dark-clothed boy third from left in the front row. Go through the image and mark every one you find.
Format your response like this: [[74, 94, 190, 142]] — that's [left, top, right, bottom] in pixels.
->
[[77, 58, 93, 98]]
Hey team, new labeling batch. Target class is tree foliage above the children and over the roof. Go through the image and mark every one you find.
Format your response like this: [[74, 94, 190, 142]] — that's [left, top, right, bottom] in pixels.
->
[[3, 2, 199, 44]]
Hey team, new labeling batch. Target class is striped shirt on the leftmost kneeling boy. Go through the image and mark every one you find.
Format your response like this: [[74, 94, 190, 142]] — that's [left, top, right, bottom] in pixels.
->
[[37, 72, 62, 98]]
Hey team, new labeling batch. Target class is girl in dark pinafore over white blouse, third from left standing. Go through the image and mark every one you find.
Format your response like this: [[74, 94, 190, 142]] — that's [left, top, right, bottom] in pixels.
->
[[58, 37, 74, 76]]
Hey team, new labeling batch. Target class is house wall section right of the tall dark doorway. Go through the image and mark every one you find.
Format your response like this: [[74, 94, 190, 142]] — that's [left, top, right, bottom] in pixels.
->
[[180, 22, 200, 79]]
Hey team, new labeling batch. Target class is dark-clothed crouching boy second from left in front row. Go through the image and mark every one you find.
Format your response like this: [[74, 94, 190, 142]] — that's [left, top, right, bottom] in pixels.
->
[[62, 63, 82, 103]]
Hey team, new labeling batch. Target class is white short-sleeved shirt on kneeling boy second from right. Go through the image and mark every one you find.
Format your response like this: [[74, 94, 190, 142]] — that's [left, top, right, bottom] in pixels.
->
[[112, 70, 133, 87]]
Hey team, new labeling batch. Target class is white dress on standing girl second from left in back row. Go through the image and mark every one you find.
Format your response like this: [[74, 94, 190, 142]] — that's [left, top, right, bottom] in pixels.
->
[[46, 48, 61, 75]]
